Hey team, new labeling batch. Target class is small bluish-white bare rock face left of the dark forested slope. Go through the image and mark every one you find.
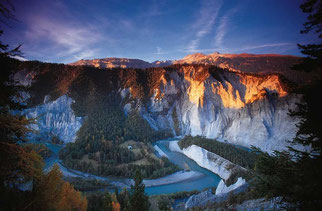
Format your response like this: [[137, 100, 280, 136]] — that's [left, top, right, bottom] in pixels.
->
[[23, 95, 82, 143]]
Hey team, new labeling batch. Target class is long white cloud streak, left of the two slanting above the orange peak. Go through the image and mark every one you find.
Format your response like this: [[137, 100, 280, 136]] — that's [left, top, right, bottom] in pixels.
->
[[186, 0, 222, 52]]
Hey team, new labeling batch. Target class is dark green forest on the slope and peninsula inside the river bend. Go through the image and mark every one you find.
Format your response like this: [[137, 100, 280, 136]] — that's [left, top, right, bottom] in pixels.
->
[[60, 67, 178, 178]]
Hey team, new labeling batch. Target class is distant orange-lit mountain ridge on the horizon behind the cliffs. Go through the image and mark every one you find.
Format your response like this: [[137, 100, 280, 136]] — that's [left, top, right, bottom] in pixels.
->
[[68, 52, 312, 83]]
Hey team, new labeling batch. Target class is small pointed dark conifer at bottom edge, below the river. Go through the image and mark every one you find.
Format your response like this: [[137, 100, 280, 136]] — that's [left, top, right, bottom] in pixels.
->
[[130, 171, 149, 211]]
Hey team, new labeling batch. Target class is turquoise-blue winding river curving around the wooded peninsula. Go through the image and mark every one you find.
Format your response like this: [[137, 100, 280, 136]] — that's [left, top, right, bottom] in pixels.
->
[[41, 138, 221, 195]]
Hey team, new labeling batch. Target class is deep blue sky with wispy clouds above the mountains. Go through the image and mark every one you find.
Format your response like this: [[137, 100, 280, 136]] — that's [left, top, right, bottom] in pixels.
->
[[0, 0, 317, 63]]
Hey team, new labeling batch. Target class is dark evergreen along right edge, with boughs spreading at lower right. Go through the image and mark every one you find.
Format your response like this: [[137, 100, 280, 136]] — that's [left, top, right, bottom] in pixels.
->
[[255, 0, 322, 210]]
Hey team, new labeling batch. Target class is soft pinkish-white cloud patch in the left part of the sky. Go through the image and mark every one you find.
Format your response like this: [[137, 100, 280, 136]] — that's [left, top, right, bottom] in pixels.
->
[[25, 16, 102, 60]]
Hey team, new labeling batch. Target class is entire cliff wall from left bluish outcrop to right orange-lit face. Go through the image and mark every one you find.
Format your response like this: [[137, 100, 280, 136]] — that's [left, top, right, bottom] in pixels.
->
[[8, 55, 300, 152]]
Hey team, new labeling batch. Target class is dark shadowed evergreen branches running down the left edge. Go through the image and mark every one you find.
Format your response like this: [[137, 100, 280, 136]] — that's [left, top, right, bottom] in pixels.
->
[[0, 1, 43, 209]]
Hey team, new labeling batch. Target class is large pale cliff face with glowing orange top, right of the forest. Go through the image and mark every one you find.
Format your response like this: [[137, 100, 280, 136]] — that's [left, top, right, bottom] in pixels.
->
[[123, 65, 299, 151]]
